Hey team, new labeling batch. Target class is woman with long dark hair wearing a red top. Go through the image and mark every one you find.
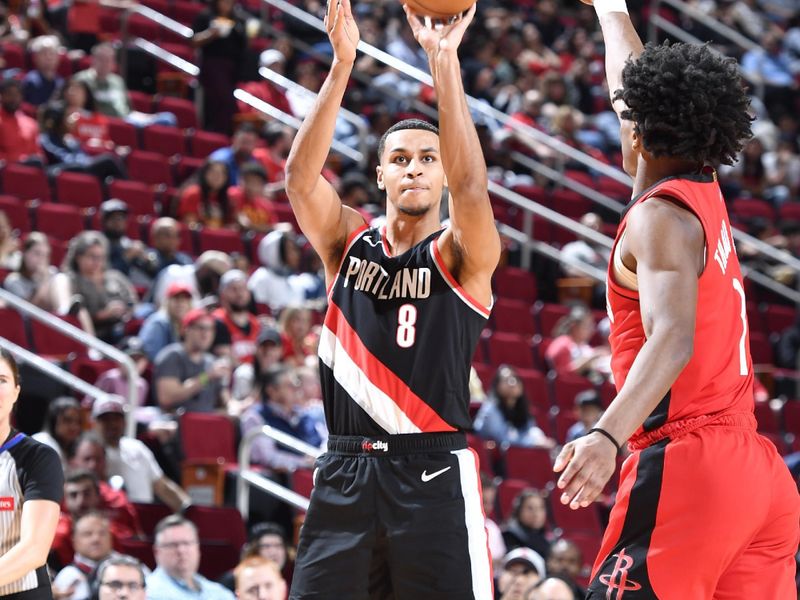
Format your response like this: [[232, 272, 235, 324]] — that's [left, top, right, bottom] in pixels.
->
[[178, 160, 237, 228]]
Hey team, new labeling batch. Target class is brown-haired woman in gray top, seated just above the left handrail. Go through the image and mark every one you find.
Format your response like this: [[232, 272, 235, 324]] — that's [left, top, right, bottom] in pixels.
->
[[55, 231, 138, 343]]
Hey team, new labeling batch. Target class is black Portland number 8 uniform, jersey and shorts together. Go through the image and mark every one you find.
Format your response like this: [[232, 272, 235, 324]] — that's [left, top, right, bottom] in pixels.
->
[[290, 226, 493, 600]]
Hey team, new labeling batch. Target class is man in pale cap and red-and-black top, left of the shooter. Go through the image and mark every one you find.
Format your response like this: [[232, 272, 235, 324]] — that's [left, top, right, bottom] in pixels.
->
[[211, 269, 260, 364]]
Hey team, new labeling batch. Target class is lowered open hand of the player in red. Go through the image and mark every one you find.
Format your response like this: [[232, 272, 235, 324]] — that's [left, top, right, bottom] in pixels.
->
[[553, 433, 617, 510]]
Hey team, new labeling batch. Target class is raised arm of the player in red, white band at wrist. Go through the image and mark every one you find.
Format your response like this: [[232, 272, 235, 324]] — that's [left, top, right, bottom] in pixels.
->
[[581, 0, 644, 115]]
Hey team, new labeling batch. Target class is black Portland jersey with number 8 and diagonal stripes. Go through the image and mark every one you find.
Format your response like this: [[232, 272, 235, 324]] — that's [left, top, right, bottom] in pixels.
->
[[319, 226, 489, 436]]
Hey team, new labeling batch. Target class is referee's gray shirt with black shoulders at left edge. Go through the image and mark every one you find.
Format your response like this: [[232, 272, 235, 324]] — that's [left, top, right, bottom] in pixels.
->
[[0, 429, 64, 600]]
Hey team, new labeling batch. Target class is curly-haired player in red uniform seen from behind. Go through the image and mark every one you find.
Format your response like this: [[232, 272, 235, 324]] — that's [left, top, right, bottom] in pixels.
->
[[555, 0, 800, 600]]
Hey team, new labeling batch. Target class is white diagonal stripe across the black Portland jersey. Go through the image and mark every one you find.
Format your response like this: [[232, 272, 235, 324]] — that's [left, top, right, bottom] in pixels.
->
[[319, 326, 421, 435]]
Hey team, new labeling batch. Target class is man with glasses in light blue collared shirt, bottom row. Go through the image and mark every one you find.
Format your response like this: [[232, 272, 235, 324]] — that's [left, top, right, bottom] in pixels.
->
[[147, 515, 234, 600]]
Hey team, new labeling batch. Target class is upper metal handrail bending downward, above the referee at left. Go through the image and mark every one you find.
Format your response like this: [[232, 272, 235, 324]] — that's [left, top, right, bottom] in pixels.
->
[[0, 288, 139, 437]]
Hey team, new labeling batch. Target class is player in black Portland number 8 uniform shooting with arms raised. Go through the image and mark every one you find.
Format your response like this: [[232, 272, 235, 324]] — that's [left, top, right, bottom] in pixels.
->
[[286, 0, 500, 600]]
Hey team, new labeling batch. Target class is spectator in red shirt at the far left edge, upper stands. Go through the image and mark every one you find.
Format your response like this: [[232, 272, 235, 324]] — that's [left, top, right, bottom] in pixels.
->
[[0, 79, 44, 164]]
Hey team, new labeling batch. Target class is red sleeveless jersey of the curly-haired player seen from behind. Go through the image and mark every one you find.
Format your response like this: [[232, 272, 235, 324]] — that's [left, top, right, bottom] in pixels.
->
[[608, 173, 753, 438]]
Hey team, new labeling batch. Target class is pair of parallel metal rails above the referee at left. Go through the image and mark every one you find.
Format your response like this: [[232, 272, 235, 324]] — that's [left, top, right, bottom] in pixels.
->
[[0, 288, 139, 437]]
